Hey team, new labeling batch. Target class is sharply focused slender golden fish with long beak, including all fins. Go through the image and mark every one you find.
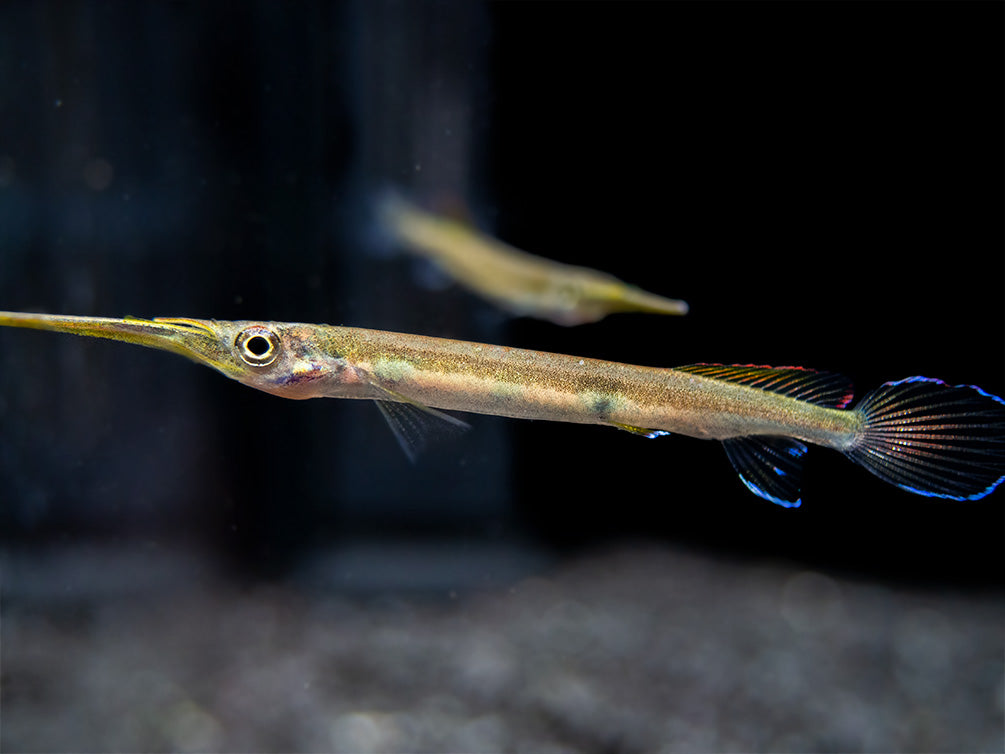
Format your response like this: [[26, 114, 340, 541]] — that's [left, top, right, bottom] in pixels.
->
[[0, 312, 1005, 507]]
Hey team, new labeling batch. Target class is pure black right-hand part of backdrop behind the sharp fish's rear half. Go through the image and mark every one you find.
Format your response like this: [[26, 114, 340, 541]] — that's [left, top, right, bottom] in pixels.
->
[[492, 4, 1005, 581]]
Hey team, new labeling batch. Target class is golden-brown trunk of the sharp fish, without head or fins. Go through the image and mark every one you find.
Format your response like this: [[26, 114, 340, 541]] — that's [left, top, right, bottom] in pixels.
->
[[327, 328, 855, 447]]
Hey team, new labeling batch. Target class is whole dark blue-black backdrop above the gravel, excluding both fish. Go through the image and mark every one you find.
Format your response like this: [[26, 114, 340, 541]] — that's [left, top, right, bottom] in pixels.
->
[[0, 2, 1005, 584]]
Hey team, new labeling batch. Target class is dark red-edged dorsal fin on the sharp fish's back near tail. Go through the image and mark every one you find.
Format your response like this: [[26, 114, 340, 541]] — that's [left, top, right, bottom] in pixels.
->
[[676, 364, 854, 408]]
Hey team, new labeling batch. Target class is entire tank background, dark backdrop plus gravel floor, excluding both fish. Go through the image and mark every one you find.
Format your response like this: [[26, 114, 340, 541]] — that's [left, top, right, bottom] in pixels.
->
[[0, 0, 1005, 751]]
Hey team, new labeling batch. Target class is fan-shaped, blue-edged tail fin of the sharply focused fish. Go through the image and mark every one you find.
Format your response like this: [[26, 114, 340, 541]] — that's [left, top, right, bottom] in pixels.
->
[[844, 377, 1005, 500]]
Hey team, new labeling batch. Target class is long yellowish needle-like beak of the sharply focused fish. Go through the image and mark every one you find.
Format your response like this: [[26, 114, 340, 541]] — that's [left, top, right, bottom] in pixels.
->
[[0, 312, 239, 377]]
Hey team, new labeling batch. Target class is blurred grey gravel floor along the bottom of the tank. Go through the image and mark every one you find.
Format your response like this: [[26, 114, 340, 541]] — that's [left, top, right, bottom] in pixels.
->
[[0, 546, 1005, 753]]
